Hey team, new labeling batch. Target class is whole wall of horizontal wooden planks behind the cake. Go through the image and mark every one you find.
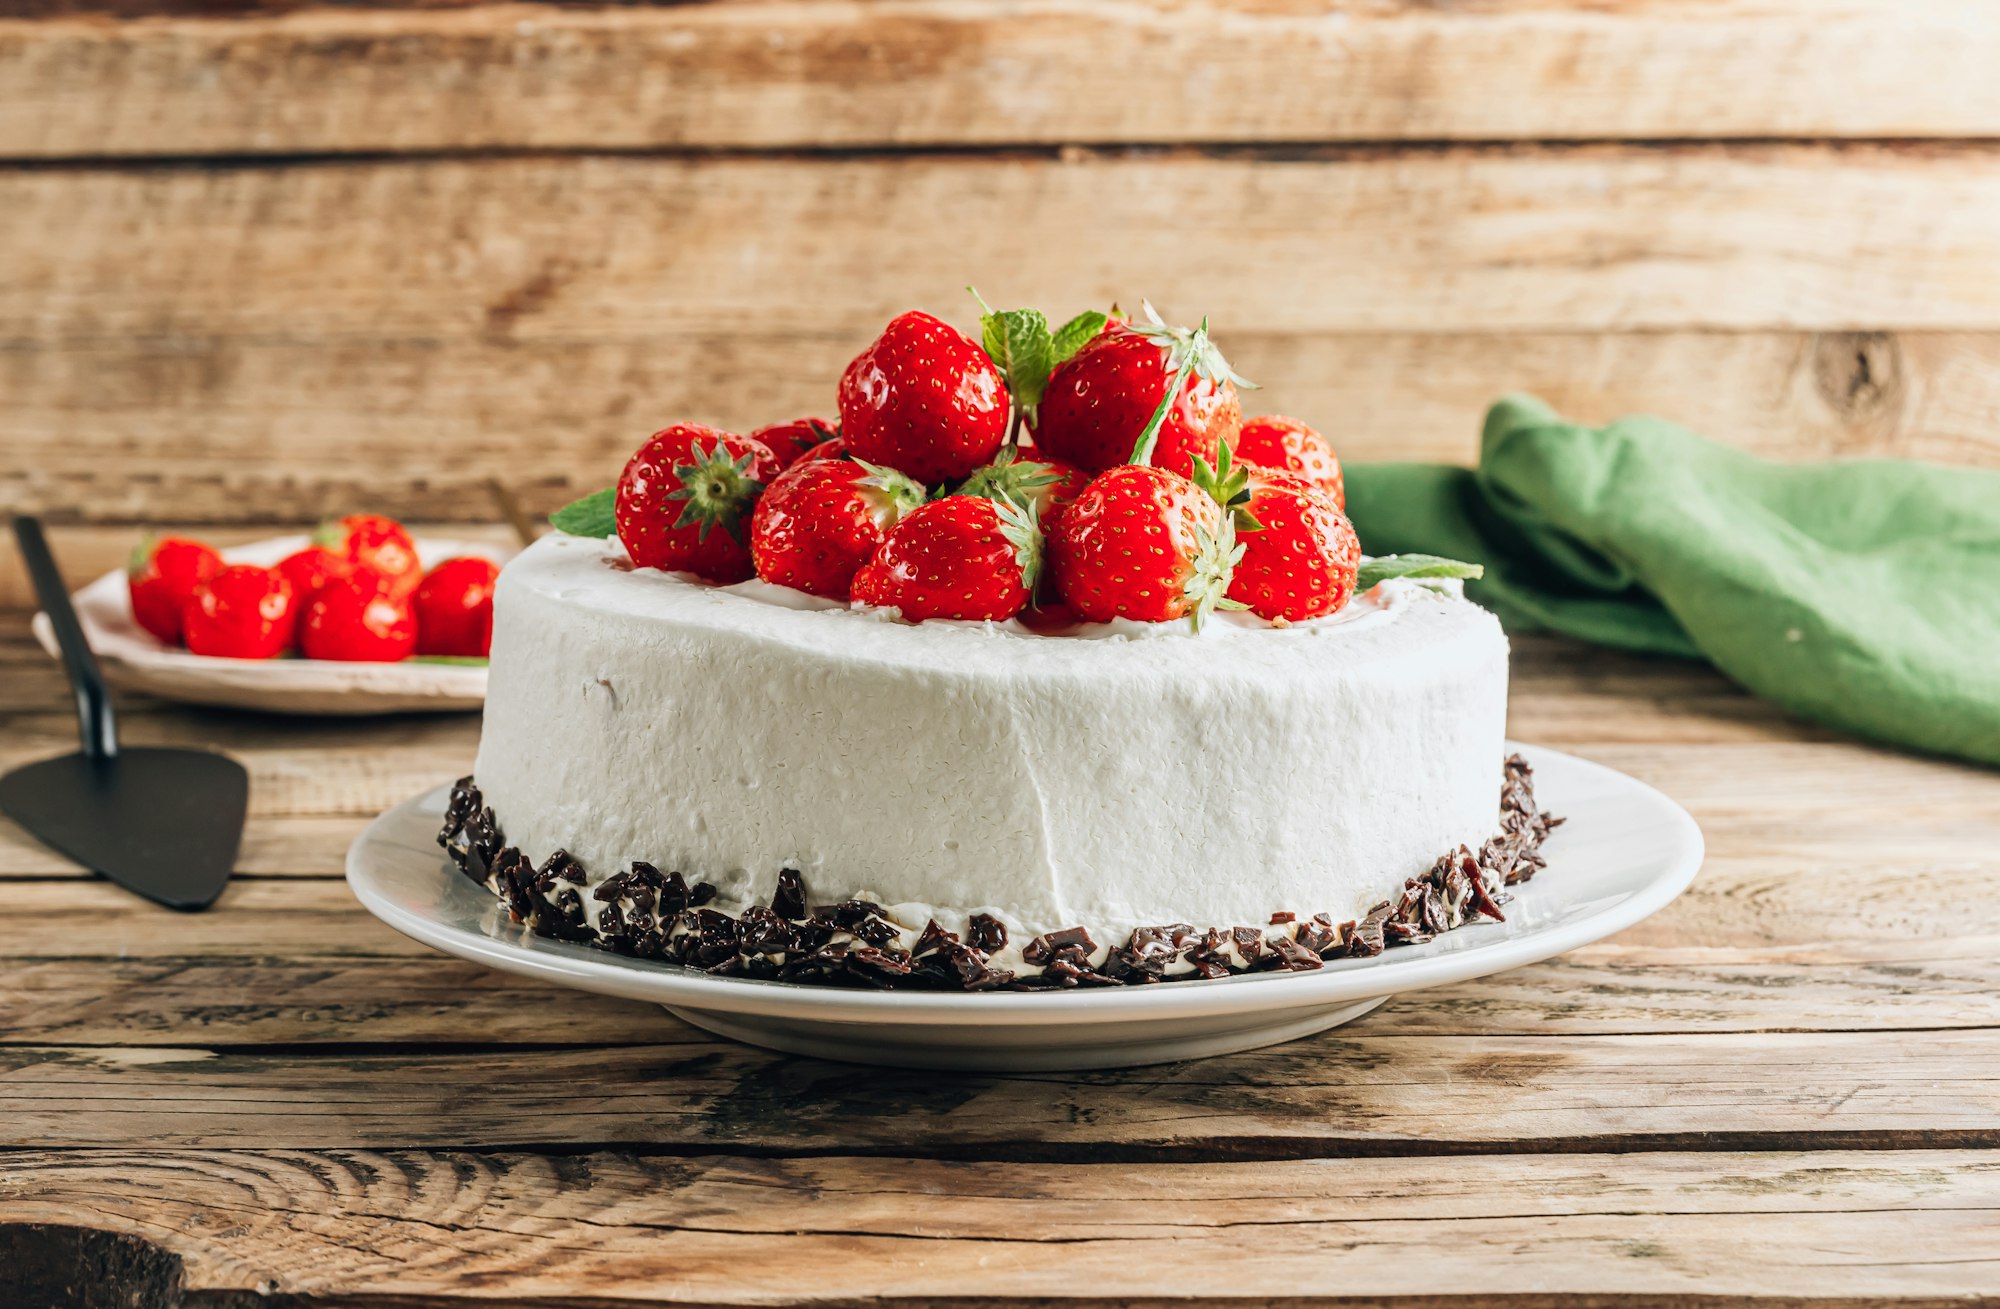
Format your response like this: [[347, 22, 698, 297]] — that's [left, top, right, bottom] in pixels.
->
[[0, 0, 2000, 602]]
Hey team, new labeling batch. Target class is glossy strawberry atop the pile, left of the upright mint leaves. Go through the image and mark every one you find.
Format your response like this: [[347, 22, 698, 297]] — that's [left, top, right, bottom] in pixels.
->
[[840, 310, 1008, 482]]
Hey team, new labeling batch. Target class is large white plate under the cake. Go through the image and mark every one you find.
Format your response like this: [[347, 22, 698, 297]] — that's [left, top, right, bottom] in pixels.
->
[[348, 747, 1702, 1073]]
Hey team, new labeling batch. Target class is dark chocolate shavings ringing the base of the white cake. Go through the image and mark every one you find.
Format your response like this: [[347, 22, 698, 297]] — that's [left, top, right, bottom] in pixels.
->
[[438, 755, 1562, 991]]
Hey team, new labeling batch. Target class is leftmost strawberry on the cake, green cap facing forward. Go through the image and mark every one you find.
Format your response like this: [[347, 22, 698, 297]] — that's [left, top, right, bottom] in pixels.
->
[[616, 422, 782, 582]]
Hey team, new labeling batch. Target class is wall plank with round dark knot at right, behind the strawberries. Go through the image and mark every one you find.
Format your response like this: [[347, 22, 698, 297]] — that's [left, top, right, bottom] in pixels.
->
[[15, 334, 2000, 540]]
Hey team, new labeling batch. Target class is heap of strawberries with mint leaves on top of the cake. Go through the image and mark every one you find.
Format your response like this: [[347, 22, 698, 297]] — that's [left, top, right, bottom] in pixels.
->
[[552, 302, 1392, 628]]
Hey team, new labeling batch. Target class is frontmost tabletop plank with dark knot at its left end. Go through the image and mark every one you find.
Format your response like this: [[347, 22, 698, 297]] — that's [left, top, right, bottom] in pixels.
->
[[0, 1151, 2000, 1309]]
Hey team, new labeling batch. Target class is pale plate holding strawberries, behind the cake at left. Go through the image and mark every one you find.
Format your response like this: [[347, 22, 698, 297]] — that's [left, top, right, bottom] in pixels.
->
[[34, 536, 512, 715]]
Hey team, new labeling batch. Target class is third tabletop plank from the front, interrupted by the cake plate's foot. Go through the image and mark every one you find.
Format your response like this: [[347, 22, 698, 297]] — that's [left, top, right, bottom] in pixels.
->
[[11, 937, 2000, 1057]]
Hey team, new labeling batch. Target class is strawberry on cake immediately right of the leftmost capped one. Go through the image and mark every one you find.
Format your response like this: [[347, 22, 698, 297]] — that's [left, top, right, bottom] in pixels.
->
[[750, 458, 924, 600]]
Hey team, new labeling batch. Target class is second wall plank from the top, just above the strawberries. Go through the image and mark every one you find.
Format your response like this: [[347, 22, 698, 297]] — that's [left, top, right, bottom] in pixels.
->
[[15, 142, 2000, 344]]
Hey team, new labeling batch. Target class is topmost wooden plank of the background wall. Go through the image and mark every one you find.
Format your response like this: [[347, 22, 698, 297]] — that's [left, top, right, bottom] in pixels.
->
[[0, 0, 2000, 156]]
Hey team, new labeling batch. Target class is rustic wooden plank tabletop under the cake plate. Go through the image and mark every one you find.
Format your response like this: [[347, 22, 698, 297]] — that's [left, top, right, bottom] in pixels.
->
[[0, 614, 2000, 1309]]
